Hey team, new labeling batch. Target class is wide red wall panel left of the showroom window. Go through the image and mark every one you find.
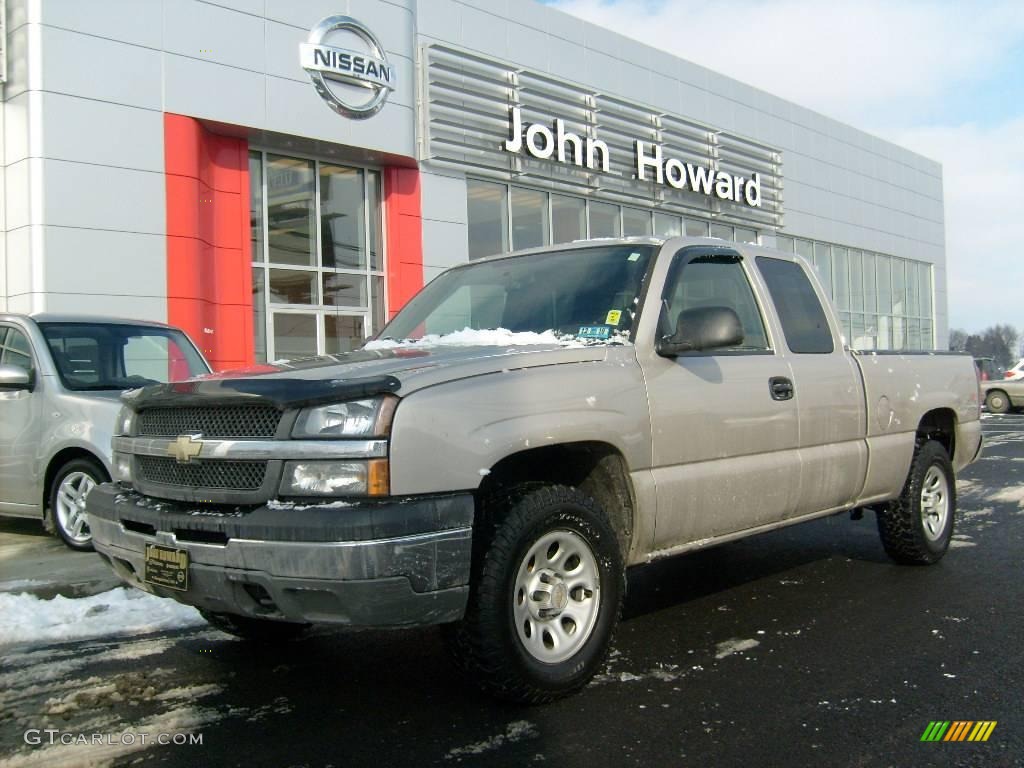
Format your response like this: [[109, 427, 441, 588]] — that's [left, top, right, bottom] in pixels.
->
[[164, 114, 254, 371]]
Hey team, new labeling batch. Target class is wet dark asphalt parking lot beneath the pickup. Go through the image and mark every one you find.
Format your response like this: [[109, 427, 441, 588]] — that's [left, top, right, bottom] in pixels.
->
[[0, 414, 1024, 767]]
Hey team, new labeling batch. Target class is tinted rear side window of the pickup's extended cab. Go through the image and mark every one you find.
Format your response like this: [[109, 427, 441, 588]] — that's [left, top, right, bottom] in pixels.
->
[[758, 256, 836, 354]]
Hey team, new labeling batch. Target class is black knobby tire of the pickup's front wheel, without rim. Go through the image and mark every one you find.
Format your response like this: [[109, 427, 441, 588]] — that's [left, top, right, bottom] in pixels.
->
[[444, 484, 626, 703]]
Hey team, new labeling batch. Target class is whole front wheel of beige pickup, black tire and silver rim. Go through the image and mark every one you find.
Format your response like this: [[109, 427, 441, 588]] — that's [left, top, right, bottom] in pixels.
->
[[449, 485, 625, 703]]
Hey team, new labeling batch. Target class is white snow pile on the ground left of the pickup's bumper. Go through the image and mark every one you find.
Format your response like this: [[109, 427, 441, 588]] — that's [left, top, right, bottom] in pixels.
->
[[0, 587, 204, 645]]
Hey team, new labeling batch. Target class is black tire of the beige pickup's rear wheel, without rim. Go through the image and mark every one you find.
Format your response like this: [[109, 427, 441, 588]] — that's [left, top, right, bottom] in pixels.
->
[[877, 440, 956, 565]]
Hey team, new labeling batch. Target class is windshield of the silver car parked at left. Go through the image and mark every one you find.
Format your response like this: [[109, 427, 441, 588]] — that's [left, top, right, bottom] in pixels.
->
[[39, 323, 210, 391]]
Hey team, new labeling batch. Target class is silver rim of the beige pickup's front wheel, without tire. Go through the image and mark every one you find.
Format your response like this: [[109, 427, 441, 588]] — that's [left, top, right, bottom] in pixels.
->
[[512, 529, 601, 664]]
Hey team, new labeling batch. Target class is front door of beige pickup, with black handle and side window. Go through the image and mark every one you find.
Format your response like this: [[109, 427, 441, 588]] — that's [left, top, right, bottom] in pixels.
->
[[638, 246, 800, 550]]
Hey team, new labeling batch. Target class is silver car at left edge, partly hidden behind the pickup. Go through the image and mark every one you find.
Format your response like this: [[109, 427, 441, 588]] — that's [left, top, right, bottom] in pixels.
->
[[0, 314, 210, 550]]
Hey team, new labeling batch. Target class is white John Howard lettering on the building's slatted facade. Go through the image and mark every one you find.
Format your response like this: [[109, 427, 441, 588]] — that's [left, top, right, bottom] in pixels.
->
[[502, 106, 761, 208]]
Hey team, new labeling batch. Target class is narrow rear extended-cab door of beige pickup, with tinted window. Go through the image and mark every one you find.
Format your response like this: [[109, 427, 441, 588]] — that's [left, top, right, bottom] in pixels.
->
[[757, 256, 867, 515]]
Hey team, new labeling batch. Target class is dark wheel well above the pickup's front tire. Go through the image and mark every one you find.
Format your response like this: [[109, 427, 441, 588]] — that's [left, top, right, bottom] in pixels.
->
[[478, 442, 634, 559]]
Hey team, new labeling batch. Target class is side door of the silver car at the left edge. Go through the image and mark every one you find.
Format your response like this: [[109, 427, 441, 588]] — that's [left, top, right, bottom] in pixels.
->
[[0, 324, 42, 515]]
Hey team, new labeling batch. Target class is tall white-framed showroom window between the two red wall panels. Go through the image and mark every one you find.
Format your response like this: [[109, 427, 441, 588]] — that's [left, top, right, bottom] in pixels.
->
[[249, 152, 384, 361]]
